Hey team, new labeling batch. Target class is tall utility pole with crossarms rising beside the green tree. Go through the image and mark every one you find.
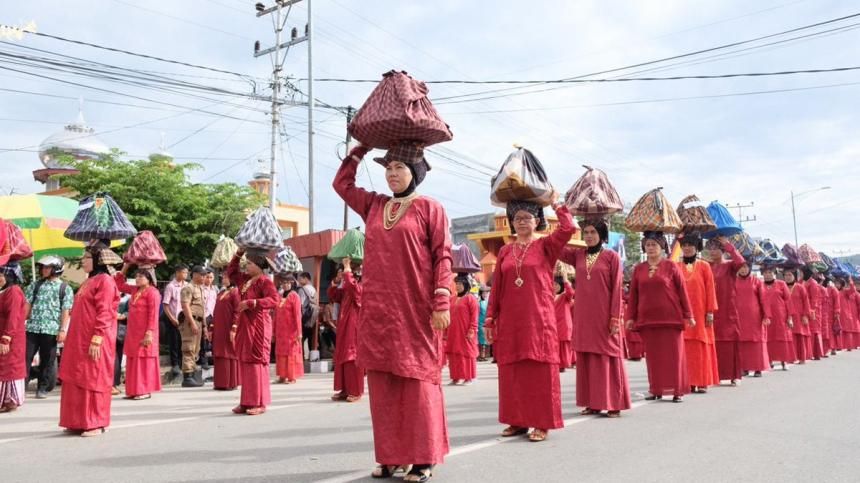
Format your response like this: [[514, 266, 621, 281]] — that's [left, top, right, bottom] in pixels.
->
[[254, 0, 313, 210]]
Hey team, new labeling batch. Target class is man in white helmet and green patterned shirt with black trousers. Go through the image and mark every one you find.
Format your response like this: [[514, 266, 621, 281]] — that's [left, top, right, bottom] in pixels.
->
[[25, 255, 74, 399]]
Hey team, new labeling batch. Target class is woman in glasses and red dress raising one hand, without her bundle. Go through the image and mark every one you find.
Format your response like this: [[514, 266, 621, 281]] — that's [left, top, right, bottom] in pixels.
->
[[484, 201, 579, 442]]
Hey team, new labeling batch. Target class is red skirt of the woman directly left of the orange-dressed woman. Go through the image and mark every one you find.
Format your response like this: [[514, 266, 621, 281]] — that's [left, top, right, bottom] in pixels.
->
[[639, 327, 690, 396]]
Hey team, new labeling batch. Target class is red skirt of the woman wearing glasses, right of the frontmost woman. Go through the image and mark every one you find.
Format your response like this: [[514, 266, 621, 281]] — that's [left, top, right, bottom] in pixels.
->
[[499, 360, 564, 430]]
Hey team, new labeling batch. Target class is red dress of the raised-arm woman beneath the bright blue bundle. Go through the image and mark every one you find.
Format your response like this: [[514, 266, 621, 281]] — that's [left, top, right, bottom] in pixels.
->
[[711, 243, 746, 381]]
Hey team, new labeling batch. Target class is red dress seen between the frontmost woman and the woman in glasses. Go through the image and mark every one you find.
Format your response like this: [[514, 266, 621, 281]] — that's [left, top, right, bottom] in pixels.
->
[[445, 293, 478, 382]]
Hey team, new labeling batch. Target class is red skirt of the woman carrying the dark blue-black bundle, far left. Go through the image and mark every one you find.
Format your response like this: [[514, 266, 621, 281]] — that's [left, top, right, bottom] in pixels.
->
[[60, 381, 111, 431]]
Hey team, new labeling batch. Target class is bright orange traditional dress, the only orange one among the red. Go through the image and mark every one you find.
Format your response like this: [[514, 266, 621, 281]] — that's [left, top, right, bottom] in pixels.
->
[[678, 260, 720, 387]]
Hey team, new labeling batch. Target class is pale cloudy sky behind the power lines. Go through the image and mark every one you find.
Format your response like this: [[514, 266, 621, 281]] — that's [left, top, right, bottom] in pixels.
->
[[0, 0, 860, 256]]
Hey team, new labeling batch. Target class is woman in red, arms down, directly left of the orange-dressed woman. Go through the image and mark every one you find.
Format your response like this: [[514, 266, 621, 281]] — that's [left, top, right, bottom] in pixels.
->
[[626, 231, 698, 402]]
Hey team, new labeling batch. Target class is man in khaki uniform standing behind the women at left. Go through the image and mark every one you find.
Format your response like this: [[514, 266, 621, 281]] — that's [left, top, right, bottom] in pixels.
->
[[179, 266, 206, 387]]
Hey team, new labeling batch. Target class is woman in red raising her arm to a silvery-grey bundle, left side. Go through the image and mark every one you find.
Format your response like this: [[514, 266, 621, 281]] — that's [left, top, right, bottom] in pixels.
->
[[226, 250, 280, 416]]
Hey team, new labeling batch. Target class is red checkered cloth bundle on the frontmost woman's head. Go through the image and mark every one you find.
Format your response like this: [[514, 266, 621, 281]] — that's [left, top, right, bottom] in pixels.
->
[[347, 70, 454, 149]]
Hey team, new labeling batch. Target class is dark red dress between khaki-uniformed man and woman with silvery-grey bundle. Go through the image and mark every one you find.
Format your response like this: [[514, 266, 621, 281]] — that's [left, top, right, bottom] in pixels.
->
[[212, 287, 241, 390]]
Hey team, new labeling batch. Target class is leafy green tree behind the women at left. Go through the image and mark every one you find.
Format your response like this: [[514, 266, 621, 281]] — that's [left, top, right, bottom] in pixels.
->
[[61, 150, 264, 278]]
